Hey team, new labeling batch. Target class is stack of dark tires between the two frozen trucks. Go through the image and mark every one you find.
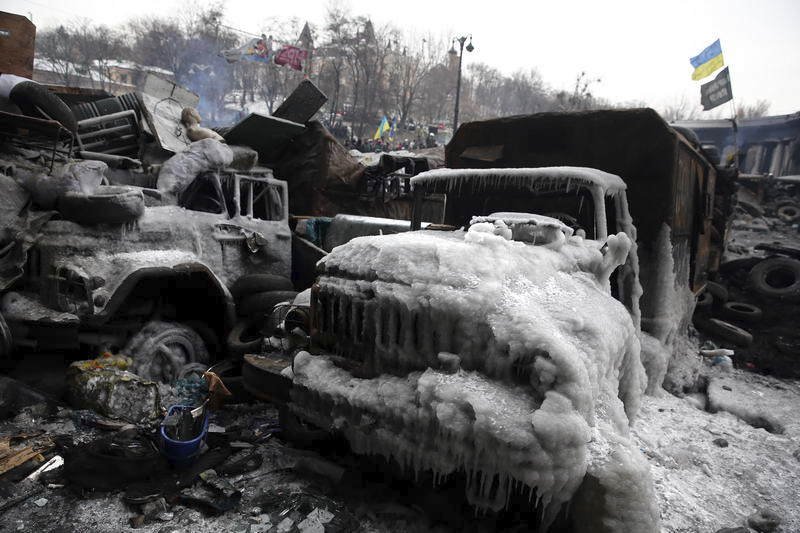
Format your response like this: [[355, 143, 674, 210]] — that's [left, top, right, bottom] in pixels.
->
[[228, 274, 297, 356]]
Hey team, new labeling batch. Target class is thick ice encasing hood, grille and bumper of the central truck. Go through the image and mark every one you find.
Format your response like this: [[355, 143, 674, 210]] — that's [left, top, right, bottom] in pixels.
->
[[292, 221, 658, 531]]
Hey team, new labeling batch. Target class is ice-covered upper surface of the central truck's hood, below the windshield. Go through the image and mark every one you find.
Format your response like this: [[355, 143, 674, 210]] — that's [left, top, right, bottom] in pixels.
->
[[320, 223, 630, 289]]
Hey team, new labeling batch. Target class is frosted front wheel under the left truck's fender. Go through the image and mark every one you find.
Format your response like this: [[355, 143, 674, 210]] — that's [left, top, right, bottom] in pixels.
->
[[122, 321, 209, 383]]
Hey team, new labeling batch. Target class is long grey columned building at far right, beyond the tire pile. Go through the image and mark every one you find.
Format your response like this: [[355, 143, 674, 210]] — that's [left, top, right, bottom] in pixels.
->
[[674, 112, 800, 176]]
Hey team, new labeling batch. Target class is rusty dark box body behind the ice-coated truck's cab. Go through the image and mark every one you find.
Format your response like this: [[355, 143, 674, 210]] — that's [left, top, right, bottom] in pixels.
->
[[446, 109, 727, 386]]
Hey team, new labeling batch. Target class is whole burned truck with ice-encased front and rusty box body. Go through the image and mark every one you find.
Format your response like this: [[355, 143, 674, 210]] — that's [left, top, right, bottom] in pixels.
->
[[282, 110, 717, 531]]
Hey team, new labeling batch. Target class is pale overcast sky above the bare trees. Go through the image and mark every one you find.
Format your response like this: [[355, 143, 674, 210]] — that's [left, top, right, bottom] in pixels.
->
[[6, 0, 800, 116]]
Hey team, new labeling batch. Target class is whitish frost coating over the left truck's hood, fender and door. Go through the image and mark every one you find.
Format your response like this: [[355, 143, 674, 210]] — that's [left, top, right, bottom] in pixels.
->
[[31, 206, 290, 314]]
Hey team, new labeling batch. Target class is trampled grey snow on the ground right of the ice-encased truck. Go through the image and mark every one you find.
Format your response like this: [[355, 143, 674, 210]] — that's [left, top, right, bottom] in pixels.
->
[[632, 371, 800, 533]]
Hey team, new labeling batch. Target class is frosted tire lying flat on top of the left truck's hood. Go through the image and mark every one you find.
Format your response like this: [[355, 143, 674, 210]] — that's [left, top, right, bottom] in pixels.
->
[[57, 185, 144, 226]]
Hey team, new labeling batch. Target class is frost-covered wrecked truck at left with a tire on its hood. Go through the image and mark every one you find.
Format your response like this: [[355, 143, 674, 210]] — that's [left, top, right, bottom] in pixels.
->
[[2, 141, 292, 382]]
